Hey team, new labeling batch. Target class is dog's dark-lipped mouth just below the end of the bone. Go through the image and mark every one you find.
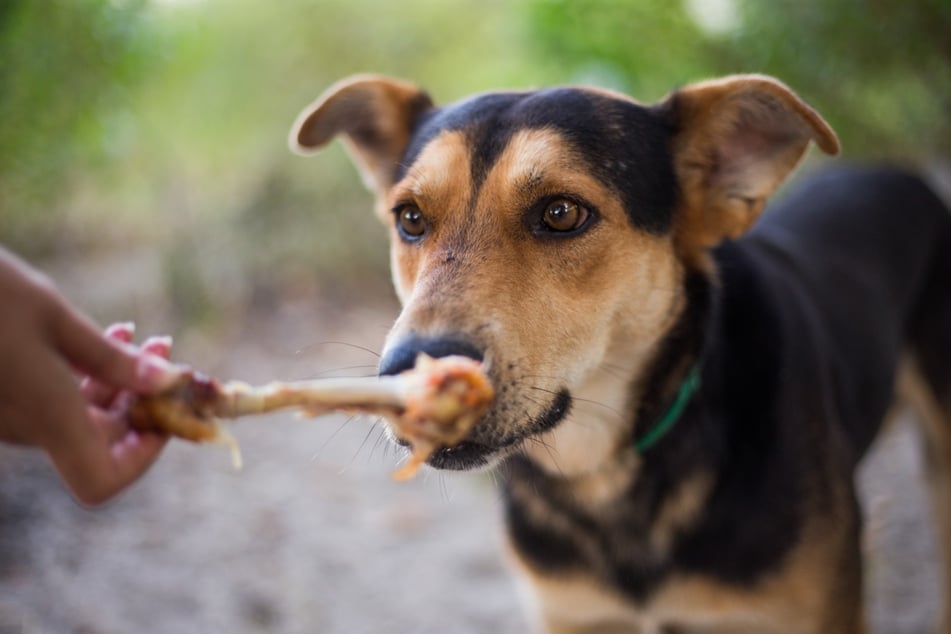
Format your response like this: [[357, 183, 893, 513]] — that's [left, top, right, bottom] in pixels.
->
[[410, 390, 571, 471]]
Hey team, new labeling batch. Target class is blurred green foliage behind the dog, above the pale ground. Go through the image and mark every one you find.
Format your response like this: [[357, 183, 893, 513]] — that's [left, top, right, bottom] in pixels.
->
[[0, 0, 951, 321]]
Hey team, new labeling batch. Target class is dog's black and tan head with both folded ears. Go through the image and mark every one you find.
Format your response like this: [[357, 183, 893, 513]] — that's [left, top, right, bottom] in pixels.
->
[[291, 76, 838, 471]]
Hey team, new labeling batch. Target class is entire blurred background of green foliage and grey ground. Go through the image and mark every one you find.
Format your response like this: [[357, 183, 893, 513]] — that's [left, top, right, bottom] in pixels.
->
[[0, 0, 951, 634]]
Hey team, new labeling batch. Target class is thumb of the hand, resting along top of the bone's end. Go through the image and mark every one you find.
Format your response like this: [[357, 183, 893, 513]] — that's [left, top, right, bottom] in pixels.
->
[[53, 306, 181, 394]]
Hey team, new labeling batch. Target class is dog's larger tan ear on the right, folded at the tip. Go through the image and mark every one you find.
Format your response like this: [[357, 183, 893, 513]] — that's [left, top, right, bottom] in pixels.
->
[[658, 75, 839, 254]]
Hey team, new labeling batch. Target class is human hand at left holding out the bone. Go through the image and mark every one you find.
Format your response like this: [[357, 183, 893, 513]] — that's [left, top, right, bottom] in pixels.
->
[[0, 249, 179, 504]]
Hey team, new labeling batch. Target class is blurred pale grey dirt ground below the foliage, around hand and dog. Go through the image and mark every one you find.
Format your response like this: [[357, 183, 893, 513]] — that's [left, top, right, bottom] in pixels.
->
[[0, 254, 938, 634]]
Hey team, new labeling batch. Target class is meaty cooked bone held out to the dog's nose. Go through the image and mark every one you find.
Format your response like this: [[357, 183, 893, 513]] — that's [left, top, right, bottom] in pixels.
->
[[131, 355, 494, 480]]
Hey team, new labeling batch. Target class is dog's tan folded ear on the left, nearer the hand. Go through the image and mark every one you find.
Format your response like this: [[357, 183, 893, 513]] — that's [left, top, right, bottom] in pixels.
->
[[290, 75, 433, 195]]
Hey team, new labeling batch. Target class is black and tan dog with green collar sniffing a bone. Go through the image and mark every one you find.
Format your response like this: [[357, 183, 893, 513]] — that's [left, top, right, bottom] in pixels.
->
[[290, 75, 951, 634]]
